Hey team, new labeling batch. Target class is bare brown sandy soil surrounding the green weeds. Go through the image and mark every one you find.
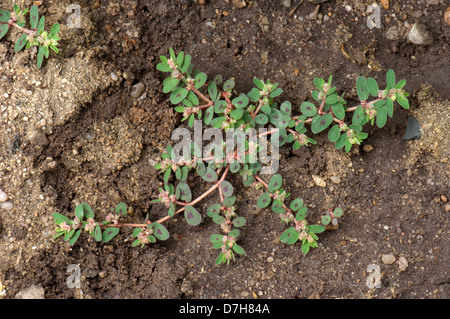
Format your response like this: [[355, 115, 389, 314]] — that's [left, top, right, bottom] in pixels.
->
[[0, 0, 450, 299]]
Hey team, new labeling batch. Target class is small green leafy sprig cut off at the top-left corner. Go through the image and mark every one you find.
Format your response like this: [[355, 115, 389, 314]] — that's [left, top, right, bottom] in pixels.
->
[[0, 4, 60, 68]]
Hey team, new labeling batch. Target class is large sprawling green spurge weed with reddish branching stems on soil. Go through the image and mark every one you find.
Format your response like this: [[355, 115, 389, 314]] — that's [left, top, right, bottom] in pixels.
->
[[51, 48, 409, 265]]
